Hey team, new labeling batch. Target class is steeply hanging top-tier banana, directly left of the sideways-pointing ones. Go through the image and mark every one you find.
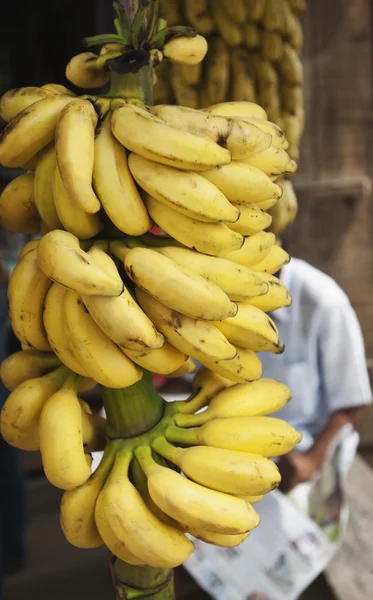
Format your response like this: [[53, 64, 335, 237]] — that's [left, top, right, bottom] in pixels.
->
[[93, 113, 151, 235]]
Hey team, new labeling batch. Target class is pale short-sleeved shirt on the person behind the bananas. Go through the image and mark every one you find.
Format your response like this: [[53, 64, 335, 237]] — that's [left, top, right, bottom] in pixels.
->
[[259, 258, 372, 451]]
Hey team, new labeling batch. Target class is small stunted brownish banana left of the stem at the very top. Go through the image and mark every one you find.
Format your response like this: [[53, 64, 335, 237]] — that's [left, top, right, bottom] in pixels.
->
[[65, 52, 110, 89]]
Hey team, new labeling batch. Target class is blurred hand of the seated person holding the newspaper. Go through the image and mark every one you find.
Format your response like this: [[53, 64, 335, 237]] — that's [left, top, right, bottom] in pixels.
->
[[278, 451, 320, 493]]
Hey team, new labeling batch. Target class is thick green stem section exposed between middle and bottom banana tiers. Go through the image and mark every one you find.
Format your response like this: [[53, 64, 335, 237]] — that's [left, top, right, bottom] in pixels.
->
[[102, 371, 165, 439]]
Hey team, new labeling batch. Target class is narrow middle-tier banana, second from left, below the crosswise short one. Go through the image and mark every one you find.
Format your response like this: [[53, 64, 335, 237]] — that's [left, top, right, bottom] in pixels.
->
[[43, 283, 88, 377]]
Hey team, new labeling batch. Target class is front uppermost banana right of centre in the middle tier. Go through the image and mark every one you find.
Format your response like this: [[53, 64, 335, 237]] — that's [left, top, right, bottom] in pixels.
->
[[124, 248, 237, 321]]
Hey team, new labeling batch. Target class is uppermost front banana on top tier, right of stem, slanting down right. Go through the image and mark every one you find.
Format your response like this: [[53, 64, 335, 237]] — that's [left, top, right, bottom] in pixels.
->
[[110, 104, 231, 171]]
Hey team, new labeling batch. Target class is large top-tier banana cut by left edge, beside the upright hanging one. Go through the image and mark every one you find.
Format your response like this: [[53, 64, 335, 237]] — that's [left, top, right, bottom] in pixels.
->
[[0, 94, 73, 167]]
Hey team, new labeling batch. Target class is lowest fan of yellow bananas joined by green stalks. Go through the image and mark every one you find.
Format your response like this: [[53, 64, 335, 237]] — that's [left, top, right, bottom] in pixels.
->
[[57, 367, 300, 568]]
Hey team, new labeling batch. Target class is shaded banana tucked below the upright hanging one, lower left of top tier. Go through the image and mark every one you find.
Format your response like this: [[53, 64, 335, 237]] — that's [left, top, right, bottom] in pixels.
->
[[52, 164, 103, 240]]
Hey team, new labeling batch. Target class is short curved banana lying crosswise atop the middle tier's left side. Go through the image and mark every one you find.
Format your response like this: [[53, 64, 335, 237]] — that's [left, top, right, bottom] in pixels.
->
[[37, 229, 124, 297]]
